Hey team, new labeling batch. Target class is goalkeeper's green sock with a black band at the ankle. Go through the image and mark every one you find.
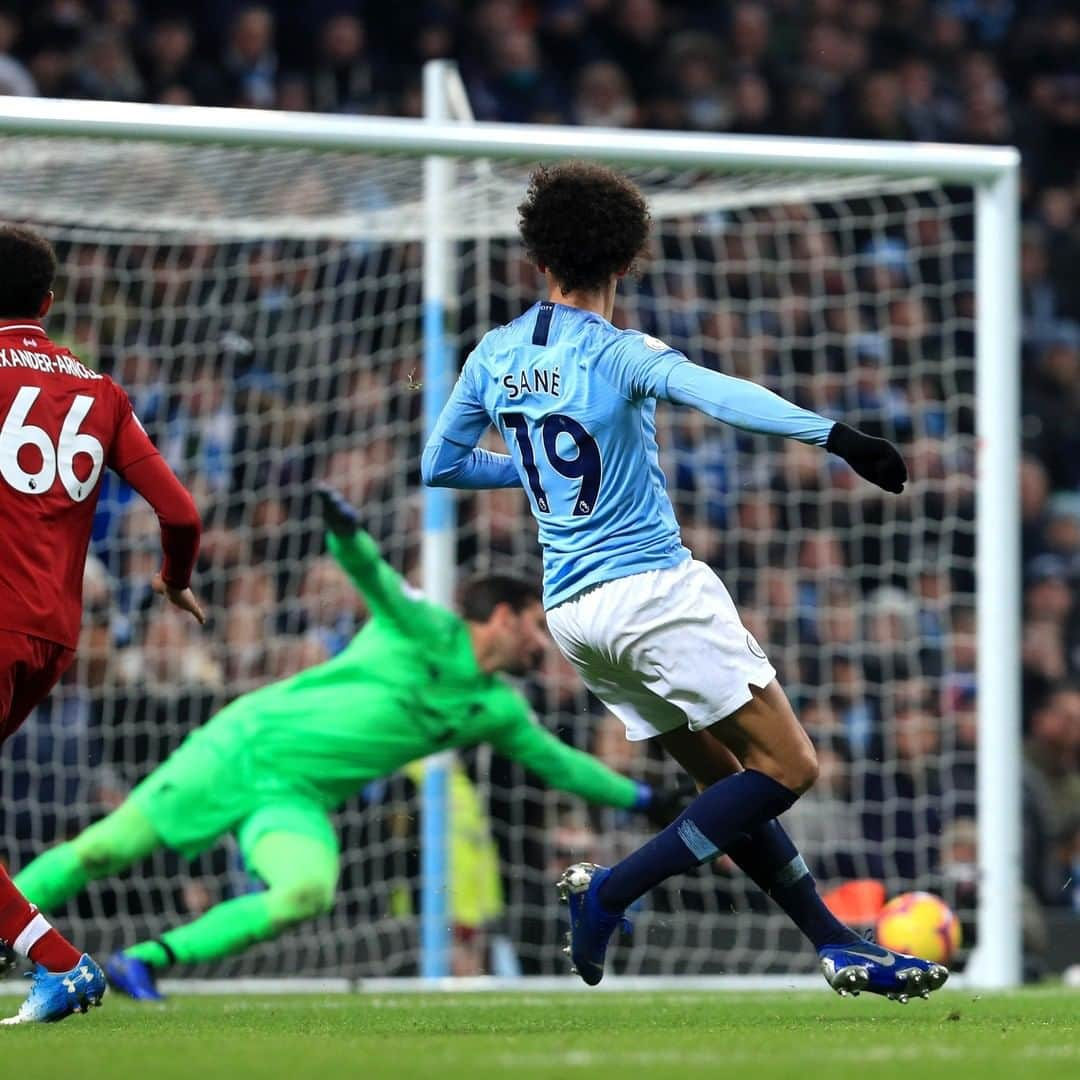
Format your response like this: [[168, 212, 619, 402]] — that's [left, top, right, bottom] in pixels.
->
[[124, 892, 278, 968]]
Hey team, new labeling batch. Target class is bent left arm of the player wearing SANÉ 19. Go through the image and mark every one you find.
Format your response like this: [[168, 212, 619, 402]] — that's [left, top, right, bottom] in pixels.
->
[[420, 354, 522, 489]]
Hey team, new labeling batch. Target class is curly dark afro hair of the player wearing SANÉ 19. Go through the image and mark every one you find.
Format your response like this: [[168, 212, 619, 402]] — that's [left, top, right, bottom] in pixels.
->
[[517, 161, 649, 293]]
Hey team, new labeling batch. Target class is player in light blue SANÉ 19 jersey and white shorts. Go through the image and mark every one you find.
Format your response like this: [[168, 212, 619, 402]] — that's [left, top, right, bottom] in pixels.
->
[[421, 162, 948, 1001]]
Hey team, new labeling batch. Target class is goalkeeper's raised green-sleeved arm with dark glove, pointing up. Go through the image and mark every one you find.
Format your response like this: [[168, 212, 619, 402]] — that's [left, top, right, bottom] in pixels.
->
[[315, 484, 419, 623]]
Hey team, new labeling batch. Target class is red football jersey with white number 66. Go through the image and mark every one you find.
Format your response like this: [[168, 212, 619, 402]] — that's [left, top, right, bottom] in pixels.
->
[[0, 320, 157, 649]]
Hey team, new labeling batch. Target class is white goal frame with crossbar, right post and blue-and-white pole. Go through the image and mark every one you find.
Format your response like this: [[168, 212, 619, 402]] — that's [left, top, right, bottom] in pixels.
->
[[0, 69, 1022, 988]]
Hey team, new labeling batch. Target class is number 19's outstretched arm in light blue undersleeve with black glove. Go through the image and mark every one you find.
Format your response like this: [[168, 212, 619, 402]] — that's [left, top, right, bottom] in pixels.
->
[[664, 361, 907, 495]]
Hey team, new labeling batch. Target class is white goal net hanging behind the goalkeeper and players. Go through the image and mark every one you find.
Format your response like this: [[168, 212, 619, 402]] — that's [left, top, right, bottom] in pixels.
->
[[0, 136, 977, 976]]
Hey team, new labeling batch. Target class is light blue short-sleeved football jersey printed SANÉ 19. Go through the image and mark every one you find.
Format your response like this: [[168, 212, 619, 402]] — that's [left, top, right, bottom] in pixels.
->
[[438, 301, 690, 608]]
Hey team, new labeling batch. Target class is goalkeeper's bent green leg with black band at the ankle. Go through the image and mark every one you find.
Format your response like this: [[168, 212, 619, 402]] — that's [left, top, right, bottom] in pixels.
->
[[118, 807, 340, 989]]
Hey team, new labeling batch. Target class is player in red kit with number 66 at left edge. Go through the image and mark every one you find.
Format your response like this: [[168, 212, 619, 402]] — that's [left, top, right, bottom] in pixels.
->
[[0, 226, 205, 1023]]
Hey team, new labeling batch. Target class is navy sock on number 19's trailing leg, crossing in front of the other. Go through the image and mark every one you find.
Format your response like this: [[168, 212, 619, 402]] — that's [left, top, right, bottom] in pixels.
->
[[596, 769, 798, 912]]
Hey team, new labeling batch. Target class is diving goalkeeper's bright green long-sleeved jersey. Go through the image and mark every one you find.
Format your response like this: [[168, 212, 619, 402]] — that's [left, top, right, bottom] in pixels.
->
[[197, 531, 638, 810]]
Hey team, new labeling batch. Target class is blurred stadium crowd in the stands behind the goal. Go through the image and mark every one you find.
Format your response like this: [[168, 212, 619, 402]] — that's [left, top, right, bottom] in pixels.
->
[[0, 0, 1080, 980]]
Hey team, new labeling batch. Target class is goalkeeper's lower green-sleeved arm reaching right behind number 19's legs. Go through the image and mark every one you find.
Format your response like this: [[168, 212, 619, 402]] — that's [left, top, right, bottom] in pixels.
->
[[491, 700, 684, 826]]
